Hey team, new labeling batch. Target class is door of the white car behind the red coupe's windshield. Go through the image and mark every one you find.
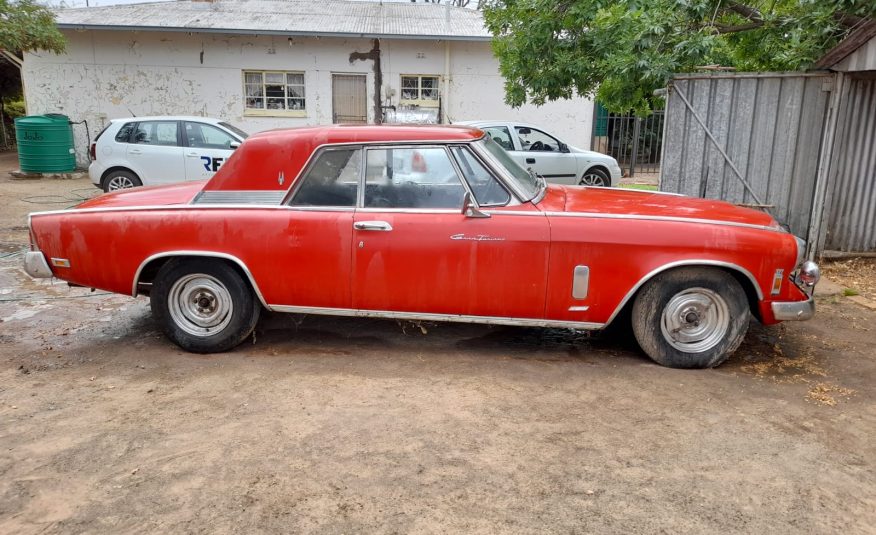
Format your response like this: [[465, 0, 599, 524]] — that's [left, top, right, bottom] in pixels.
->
[[511, 125, 579, 184]]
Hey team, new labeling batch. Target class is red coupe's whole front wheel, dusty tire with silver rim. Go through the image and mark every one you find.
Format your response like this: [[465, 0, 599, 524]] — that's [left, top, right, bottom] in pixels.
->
[[632, 268, 751, 368]]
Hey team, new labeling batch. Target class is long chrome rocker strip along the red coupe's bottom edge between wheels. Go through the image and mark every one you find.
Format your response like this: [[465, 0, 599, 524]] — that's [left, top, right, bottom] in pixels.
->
[[269, 305, 605, 330]]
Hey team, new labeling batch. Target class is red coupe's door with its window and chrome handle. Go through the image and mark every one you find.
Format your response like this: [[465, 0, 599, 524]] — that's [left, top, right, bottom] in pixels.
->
[[352, 146, 549, 318]]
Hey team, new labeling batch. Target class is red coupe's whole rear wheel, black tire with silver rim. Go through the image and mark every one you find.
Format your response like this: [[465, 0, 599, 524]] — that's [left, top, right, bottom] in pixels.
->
[[149, 258, 261, 353]]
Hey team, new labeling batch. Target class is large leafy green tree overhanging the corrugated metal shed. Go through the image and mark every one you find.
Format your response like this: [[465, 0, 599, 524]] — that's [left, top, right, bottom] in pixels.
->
[[484, 0, 876, 114]]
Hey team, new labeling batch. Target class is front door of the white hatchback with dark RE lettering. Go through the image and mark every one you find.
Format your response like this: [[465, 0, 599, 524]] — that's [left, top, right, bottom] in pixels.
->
[[182, 121, 240, 180]]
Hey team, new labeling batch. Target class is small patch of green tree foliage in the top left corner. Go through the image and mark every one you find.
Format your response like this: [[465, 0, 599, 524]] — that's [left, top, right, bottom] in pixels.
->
[[0, 0, 66, 53]]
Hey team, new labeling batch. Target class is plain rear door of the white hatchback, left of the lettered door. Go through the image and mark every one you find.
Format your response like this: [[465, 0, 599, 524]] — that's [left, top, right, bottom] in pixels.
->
[[125, 120, 186, 185]]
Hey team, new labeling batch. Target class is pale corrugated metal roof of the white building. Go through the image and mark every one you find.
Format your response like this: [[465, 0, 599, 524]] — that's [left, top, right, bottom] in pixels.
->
[[56, 0, 491, 41]]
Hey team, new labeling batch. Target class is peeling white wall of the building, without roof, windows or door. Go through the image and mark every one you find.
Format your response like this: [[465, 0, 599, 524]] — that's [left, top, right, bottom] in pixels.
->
[[23, 31, 593, 165]]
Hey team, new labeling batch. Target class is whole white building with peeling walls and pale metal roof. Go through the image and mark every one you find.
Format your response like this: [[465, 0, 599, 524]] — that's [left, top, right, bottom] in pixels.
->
[[22, 0, 593, 165]]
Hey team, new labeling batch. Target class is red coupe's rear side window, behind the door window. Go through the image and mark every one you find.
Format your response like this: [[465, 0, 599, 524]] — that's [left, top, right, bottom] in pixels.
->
[[289, 149, 362, 207]]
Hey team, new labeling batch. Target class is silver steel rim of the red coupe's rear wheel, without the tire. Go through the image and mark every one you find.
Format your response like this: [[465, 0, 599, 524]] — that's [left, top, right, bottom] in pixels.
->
[[167, 273, 234, 337]]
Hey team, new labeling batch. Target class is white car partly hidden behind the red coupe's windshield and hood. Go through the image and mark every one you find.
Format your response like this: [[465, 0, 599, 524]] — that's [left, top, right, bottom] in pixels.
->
[[455, 121, 623, 186]]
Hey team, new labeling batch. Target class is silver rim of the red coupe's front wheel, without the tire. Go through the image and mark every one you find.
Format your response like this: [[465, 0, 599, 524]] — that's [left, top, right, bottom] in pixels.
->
[[660, 288, 730, 353]]
